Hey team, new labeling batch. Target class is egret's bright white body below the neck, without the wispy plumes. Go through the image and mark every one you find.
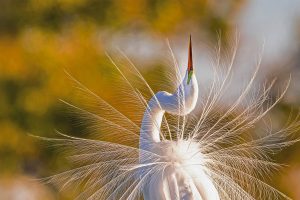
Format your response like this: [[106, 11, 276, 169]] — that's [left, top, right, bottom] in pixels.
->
[[143, 140, 219, 200]]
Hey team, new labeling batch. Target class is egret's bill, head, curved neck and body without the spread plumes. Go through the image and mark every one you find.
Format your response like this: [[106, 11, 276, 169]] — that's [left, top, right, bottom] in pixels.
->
[[140, 36, 219, 200]]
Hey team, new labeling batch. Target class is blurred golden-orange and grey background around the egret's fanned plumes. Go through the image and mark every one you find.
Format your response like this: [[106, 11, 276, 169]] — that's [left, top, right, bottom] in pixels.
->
[[0, 0, 300, 200]]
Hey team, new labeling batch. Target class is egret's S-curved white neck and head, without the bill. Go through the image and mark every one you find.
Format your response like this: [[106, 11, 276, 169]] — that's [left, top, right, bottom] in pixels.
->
[[140, 73, 198, 150]]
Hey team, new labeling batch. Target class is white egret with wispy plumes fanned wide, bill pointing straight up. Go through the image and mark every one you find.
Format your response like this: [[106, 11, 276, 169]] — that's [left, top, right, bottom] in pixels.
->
[[36, 38, 300, 200]]
